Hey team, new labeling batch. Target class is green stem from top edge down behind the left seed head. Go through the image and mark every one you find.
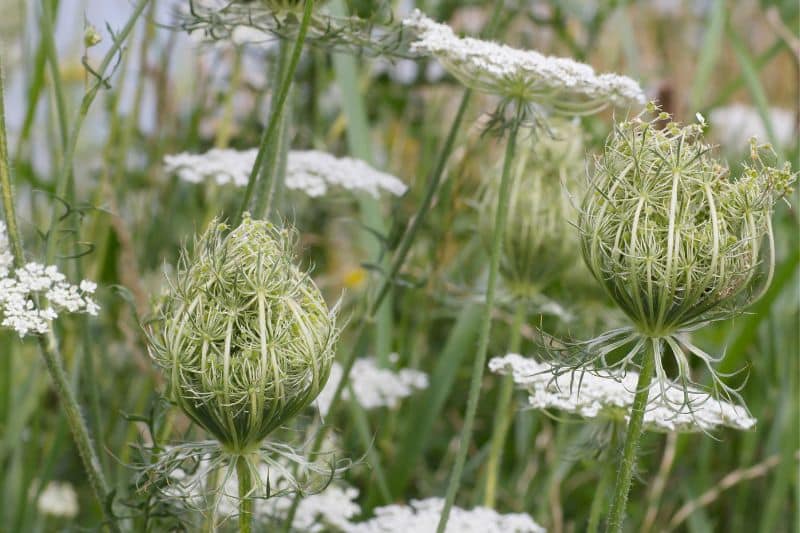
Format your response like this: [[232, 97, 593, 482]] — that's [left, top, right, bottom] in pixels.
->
[[234, 0, 314, 220]]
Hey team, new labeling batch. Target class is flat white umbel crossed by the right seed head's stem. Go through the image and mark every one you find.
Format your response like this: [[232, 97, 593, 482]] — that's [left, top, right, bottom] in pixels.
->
[[489, 354, 756, 432]]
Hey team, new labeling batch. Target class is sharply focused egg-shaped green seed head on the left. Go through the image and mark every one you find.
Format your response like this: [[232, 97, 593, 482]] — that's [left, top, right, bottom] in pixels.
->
[[150, 216, 336, 453]]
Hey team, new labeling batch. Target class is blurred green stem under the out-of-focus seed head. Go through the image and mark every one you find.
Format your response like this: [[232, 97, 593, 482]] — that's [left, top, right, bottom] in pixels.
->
[[483, 299, 525, 508]]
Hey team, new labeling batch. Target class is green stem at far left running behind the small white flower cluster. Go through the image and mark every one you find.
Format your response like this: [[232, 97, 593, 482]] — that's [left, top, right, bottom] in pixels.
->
[[0, 59, 117, 531]]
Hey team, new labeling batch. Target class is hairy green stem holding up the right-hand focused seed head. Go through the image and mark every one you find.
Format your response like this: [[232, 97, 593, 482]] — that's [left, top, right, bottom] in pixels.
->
[[606, 339, 661, 533]]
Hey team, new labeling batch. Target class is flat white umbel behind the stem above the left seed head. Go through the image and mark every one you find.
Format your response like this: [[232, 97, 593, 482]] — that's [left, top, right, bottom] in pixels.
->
[[164, 148, 408, 198]]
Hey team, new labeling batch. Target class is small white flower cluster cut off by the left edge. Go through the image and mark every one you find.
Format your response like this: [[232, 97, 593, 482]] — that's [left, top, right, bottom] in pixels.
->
[[0, 223, 100, 337]]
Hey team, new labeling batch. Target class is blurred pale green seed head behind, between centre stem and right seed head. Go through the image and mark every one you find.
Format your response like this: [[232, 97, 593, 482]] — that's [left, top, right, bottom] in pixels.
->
[[480, 120, 584, 297]]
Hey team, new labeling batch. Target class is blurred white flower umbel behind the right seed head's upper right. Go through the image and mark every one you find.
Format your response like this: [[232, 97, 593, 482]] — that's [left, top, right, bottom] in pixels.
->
[[709, 104, 797, 152]]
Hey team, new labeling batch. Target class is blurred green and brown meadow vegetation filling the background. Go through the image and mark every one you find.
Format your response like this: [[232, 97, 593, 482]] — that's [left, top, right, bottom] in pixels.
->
[[0, 0, 800, 533]]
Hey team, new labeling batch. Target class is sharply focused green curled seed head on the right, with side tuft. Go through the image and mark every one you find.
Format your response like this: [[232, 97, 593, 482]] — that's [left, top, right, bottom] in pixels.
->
[[579, 107, 795, 337]]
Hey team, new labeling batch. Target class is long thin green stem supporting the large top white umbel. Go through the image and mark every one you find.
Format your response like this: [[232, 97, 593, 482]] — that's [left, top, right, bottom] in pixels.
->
[[437, 107, 521, 533]]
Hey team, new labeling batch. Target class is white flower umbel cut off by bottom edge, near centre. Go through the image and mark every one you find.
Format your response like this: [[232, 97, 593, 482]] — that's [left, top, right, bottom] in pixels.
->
[[345, 498, 545, 533]]
